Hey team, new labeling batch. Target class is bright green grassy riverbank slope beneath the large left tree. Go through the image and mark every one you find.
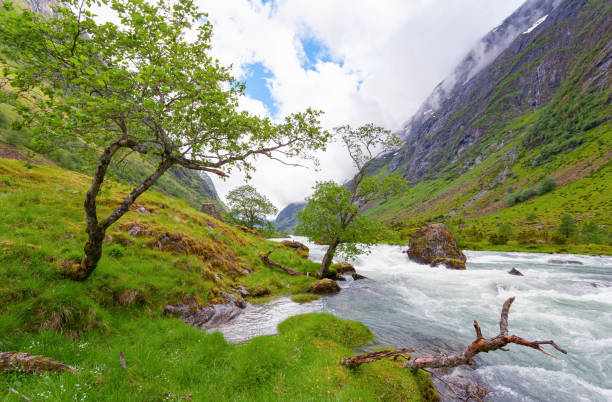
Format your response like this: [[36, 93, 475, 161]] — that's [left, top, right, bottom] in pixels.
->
[[0, 159, 433, 400]]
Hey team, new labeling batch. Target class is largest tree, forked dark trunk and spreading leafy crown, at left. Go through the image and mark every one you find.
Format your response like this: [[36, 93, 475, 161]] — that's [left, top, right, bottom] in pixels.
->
[[0, 0, 329, 279]]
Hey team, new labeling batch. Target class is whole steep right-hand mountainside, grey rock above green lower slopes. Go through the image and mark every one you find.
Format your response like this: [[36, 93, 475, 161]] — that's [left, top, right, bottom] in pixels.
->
[[371, 0, 612, 248]]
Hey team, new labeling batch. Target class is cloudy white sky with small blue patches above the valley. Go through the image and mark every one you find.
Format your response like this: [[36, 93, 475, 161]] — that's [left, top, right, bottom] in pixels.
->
[[197, 0, 522, 210]]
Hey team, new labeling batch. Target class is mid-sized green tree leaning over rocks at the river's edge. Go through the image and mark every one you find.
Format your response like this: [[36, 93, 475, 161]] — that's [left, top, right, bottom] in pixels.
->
[[296, 124, 408, 277]]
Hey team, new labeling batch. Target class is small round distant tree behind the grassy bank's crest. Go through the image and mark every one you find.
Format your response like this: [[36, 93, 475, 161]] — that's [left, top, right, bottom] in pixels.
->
[[226, 185, 278, 230]]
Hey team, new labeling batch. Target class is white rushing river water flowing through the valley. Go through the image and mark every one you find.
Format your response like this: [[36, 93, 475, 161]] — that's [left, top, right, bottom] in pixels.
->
[[214, 238, 612, 401]]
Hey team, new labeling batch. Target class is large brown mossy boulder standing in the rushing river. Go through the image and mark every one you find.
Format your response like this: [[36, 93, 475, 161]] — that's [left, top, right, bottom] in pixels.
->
[[407, 223, 466, 269]]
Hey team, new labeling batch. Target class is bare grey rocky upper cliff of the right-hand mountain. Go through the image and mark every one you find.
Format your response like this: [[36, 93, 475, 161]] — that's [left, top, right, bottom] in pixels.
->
[[380, 0, 612, 182]]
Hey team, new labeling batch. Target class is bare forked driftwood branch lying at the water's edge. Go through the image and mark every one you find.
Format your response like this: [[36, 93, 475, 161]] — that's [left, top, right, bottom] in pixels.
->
[[340, 297, 567, 370]]
